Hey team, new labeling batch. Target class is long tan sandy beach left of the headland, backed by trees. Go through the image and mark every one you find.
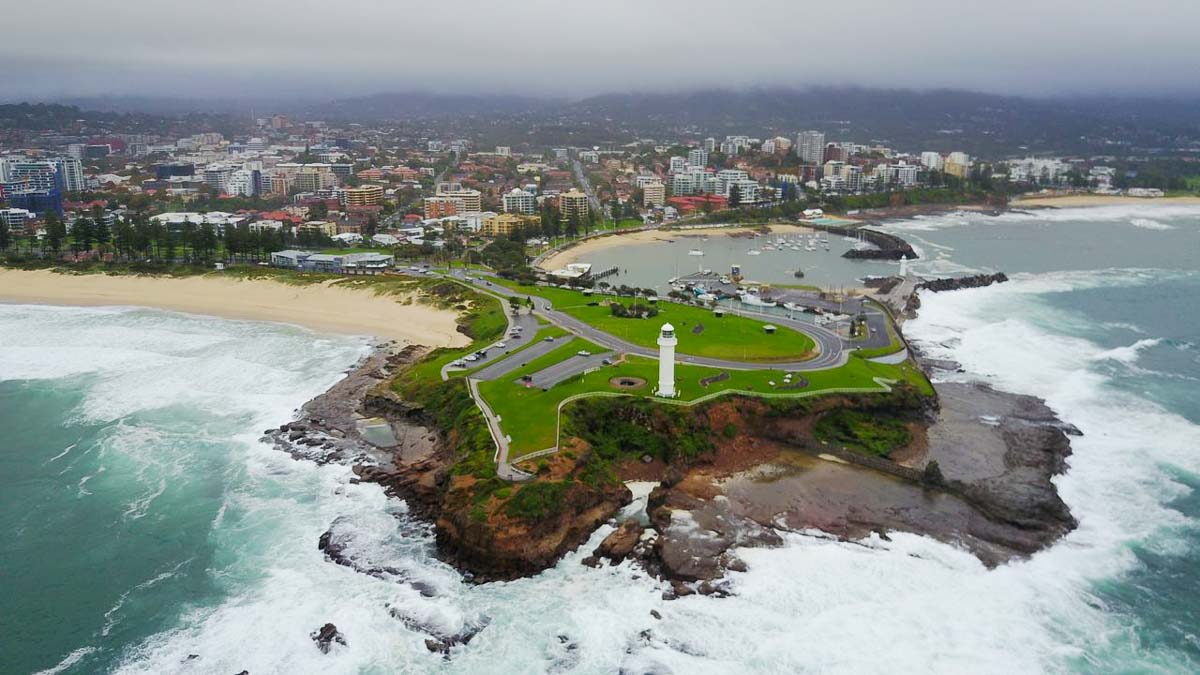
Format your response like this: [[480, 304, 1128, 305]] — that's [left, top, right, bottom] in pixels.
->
[[0, 269, 469, 347]]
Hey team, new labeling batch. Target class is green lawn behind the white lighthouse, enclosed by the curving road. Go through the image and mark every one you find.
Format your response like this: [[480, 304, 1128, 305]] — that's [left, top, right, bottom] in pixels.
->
[[496, 280, 815, 363]]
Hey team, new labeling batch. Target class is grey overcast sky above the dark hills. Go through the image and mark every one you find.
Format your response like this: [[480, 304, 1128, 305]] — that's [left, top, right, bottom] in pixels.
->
[[9, 0, 1200, 100]]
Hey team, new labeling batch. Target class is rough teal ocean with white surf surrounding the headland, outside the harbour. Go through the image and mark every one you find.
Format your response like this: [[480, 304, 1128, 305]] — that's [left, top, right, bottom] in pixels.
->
[[0, 204, 1200, 675]]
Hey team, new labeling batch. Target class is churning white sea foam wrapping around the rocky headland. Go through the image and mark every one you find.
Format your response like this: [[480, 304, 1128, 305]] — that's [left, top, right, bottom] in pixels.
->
[[11, 279, 1198, 674]]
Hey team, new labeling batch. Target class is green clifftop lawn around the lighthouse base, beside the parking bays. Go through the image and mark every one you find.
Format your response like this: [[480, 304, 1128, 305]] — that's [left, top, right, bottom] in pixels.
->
[[479, 339, 932, 451]]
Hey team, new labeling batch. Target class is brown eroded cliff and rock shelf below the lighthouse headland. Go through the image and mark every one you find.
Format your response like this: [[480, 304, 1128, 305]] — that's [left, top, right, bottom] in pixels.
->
[[270, 341, 1078, 596]]
